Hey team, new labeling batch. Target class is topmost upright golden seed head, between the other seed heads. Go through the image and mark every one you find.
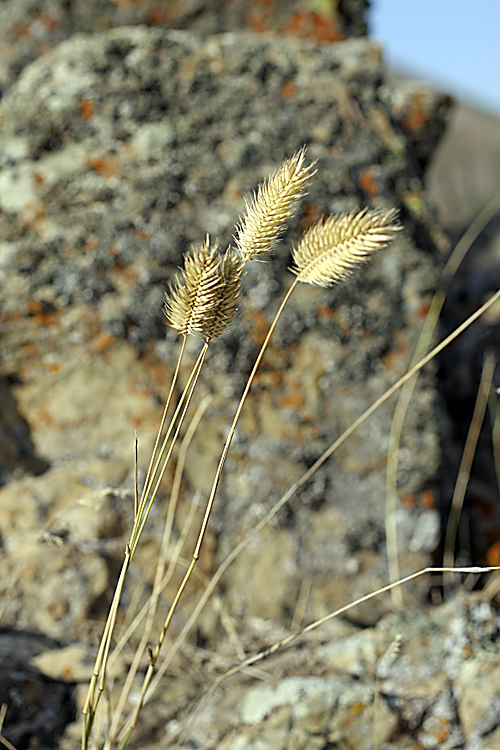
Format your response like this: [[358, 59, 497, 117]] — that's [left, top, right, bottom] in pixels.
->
[[234, 147, 315, 263]]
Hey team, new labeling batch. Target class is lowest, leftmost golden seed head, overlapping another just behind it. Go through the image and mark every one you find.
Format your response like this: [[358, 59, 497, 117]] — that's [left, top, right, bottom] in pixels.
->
[[165, 235, 221, 336]]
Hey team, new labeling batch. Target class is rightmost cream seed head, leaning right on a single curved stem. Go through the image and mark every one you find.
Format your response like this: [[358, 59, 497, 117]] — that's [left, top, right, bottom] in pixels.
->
[[292, 208, 402, 286]]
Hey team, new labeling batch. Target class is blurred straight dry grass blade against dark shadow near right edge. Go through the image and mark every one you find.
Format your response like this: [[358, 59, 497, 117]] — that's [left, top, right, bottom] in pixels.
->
[[443, 352, 496, 590]]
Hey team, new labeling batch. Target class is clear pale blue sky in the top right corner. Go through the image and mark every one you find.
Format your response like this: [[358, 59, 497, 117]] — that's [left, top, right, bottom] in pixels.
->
[[368, 0, 500, 115]]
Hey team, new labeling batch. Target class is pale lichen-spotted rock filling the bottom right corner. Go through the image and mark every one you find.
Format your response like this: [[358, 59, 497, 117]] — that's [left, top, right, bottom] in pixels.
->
[[123, 594, 498, 750]]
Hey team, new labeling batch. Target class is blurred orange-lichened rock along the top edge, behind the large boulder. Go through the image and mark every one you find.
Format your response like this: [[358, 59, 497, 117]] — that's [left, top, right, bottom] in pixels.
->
[[0, 0, 368, 94]]
